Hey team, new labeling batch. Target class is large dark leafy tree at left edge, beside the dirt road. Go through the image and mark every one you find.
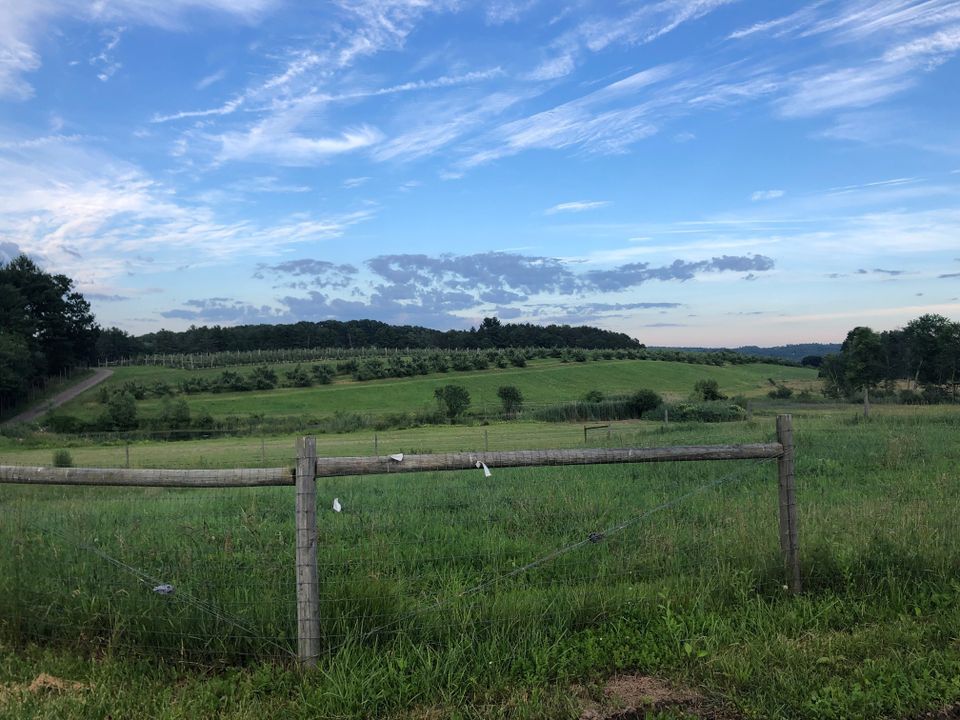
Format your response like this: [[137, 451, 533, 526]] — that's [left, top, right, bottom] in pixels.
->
[[0, 255, 100, 405]]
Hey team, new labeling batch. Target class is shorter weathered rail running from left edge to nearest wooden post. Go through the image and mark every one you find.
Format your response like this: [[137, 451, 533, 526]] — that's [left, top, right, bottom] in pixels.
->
[[0, 465, 296, 487]]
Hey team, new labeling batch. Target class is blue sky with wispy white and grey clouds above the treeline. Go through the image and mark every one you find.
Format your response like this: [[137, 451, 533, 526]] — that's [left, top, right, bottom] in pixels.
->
[[0, 0, 960, 346]]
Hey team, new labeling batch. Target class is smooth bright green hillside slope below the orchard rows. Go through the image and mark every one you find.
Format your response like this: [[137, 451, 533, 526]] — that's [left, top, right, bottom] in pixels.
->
[[52, 359, 819, 420]]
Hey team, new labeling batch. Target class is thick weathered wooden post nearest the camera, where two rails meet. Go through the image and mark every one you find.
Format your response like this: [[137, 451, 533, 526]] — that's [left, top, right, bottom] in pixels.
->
[[297, 437, 320, 668]]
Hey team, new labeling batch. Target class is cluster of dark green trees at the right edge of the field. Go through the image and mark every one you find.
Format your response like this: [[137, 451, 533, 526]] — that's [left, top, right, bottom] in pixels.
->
[[820, 314, 960, 403]]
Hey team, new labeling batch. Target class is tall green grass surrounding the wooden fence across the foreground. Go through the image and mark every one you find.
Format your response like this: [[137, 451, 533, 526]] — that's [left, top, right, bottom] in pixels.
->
[[0, 407, 960, 718]]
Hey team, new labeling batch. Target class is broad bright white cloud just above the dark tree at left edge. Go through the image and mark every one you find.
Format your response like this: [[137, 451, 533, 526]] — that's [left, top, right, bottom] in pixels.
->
[[0, 135, 373, 288]]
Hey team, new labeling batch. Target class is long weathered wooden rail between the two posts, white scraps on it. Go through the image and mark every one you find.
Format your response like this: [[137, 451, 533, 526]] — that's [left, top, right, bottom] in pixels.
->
[[317, 443, 783, 477]]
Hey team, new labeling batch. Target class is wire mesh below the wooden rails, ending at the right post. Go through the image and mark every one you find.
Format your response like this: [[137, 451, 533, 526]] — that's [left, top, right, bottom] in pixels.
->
[[0, 450, 782, 662]]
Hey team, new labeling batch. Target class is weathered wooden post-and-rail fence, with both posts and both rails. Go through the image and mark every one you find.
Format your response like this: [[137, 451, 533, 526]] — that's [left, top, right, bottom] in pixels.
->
[[0, 415, 801, 667]]
